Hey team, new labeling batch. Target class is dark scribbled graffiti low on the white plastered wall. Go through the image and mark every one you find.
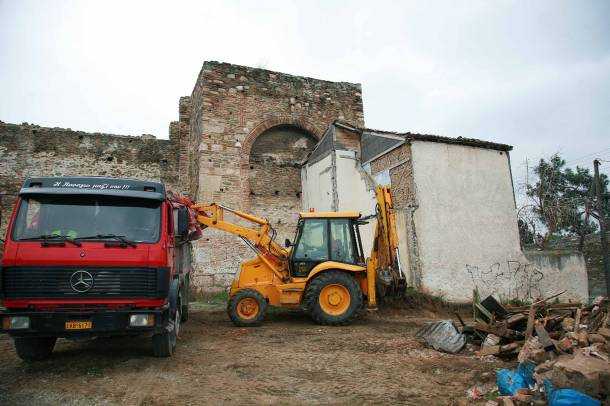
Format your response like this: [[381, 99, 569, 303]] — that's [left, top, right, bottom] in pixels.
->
[[466, 260, 544, 300]]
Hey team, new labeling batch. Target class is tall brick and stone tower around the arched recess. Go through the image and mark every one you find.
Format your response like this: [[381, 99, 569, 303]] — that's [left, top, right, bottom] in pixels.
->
[[189, 62, 364, 290]]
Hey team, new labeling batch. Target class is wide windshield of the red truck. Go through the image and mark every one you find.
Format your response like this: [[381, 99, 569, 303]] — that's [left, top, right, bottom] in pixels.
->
[[12, 195, 161, 243]]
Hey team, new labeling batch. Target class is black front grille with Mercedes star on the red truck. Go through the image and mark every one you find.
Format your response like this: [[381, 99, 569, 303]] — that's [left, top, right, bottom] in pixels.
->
[[2, 267, 169, 299]]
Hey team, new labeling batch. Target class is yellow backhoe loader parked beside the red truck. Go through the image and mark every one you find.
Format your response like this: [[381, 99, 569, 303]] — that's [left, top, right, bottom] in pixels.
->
[[192, 186, 406, 326]]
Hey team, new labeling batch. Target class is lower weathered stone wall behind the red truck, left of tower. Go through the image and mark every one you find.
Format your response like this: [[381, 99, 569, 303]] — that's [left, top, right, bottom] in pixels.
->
[[0, 122, 180, 254]]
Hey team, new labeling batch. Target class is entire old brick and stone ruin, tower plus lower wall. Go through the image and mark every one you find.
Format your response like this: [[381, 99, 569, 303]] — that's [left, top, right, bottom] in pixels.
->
[[0, 62, 364, 289]]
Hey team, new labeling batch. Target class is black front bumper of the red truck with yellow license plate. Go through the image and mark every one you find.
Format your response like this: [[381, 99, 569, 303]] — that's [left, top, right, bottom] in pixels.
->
[[0, 305, 173, 338]]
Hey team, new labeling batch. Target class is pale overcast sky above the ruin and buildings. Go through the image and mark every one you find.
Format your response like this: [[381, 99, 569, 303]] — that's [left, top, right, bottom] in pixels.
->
[[0, 0, 610, 195]]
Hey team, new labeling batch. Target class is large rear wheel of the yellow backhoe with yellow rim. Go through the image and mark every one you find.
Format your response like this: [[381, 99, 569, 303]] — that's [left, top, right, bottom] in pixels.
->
[[305, 271, 362, 326]]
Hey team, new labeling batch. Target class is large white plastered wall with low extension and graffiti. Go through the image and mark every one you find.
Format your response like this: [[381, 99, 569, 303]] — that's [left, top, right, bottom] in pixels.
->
[[411, 141, 587, 302]]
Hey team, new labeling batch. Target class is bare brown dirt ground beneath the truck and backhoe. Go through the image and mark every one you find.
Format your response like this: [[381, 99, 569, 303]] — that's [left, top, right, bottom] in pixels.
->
[[0, 304, 510, 405]]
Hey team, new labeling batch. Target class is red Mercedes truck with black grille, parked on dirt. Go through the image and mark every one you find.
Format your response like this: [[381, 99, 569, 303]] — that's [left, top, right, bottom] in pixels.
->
[[0, 177, 201, 361]]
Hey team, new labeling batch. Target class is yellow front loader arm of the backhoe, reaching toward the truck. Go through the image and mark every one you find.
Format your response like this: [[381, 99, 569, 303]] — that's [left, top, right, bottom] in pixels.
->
[[191, 203, 289, 281]]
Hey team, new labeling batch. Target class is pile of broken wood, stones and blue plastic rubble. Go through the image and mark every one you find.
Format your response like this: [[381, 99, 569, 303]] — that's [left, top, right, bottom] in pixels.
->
[[460, 295, 610, 405]]
